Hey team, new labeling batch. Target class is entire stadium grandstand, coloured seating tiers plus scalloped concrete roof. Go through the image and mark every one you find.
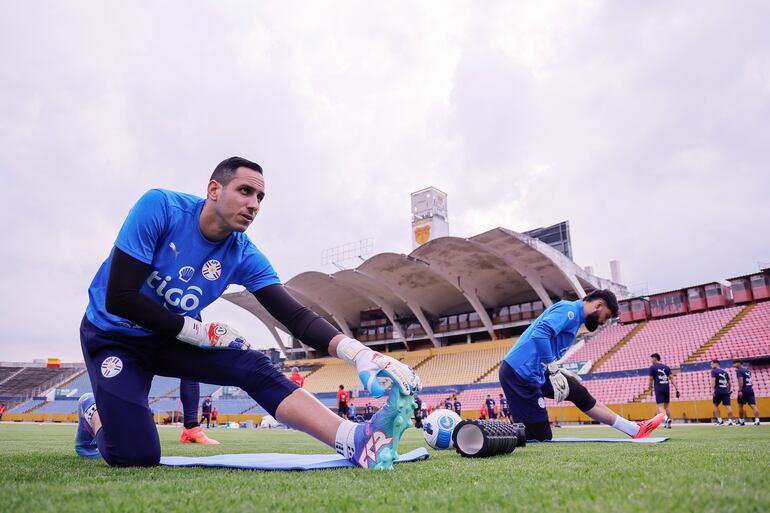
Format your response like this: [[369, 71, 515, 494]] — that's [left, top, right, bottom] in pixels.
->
[[0, 204, 770, 422]]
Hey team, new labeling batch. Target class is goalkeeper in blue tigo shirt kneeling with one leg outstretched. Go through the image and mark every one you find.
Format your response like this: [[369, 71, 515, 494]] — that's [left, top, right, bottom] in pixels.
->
[[75, 157, 420, 468]]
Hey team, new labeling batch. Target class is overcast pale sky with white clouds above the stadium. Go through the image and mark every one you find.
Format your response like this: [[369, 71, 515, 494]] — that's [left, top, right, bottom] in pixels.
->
[[0, 1, 770, 361]]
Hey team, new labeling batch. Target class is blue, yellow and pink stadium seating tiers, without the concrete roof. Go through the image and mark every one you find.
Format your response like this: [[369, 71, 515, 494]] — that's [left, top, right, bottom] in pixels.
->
[[0, 269, 770, 423]]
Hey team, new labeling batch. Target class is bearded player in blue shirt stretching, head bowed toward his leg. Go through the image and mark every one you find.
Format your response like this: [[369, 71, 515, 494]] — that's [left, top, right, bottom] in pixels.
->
[[500, 290, 665, 441]]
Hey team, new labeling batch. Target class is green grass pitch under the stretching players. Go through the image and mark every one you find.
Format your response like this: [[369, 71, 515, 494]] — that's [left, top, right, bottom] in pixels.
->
[[0, 422, 770, 513]]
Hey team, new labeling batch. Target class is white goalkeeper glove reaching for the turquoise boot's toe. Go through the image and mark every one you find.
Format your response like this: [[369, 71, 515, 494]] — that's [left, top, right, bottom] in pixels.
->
[[337, 337, 422, 397]]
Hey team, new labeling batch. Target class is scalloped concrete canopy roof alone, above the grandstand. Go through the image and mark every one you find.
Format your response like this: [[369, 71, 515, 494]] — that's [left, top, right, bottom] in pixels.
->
[[223, 228, 628, 352]]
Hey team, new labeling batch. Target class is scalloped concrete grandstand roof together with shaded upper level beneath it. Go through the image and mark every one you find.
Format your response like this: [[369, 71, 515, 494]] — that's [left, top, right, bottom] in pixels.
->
[[223, 228, 628, 359]]
